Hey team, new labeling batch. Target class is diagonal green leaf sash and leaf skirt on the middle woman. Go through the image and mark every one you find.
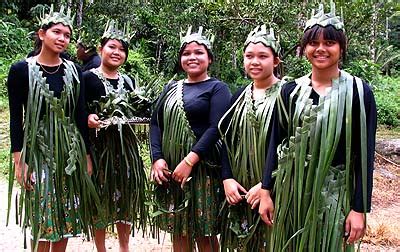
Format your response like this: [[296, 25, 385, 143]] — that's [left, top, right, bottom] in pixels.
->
[[149, 81, 220, 248]]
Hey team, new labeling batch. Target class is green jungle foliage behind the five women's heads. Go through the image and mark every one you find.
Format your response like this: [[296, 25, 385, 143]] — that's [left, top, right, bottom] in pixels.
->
[[0, 0, 400, 126]]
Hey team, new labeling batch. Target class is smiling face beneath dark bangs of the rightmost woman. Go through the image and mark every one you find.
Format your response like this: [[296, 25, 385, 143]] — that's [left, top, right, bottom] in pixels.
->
[[305, 34, 341, 70]]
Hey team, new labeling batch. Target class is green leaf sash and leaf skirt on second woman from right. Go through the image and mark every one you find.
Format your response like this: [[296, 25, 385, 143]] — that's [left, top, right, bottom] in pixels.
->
[[219, 82, 281, 251]]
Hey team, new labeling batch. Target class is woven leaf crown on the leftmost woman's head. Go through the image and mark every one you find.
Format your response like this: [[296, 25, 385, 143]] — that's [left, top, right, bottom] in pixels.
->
[[39, 5, 75, 30]]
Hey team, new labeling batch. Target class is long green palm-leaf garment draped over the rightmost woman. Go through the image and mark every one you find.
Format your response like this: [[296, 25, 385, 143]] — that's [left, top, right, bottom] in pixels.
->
[[269, 71, 367, 251]]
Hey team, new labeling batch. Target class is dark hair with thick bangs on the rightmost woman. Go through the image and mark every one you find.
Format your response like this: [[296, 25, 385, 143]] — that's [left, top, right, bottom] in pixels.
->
[[300, 25, 347, 60]]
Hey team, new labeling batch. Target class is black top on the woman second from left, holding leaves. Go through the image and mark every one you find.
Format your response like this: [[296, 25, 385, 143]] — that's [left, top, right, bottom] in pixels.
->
[[83, 71, 134, 104]]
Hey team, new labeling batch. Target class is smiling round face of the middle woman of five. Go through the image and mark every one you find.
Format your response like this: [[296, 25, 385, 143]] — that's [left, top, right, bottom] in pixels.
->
[[180, 42, 211, 82]]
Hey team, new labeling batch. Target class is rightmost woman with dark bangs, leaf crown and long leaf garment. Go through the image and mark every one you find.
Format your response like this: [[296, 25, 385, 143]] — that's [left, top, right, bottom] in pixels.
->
[[259, 2, 376, 251]]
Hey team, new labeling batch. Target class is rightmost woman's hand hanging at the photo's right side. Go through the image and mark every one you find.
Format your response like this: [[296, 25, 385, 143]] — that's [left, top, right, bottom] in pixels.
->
[[344, 210, 365, 243]]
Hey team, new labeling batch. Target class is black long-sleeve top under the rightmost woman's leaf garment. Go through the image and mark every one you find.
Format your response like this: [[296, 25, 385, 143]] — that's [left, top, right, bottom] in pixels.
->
[[262, 80, 377, 212]]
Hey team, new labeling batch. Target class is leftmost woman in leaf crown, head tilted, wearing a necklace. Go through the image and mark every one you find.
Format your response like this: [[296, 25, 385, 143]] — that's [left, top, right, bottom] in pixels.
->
[[7, 7, 98, 251]]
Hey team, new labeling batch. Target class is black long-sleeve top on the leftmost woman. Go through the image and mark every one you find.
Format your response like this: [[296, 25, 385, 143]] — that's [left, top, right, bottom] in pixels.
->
[[7, 60, 89, 152]]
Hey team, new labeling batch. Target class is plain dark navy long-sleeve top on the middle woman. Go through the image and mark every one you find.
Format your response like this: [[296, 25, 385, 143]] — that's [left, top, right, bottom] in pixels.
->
[[150, 78, 231, 162]]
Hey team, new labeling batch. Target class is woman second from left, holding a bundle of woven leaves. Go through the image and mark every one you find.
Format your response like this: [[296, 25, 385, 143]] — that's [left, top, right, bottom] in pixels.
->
[[83, 21, 147, 251]]
